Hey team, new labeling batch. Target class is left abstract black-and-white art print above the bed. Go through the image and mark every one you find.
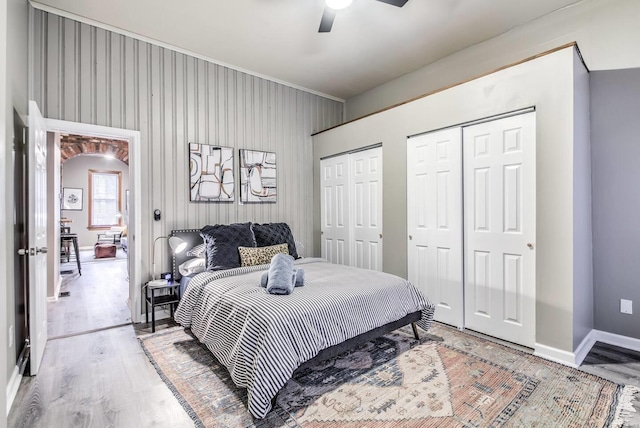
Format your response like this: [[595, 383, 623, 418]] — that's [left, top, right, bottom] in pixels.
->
[[189, 143, 234, 202]]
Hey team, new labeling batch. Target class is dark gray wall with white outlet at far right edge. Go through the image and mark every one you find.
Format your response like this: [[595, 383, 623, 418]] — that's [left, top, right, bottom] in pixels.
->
[[591, 68, 640, 339]]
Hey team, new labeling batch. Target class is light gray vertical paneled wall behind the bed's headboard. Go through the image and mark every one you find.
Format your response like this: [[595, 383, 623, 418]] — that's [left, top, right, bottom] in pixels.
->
[[32, 10, 343, 277]]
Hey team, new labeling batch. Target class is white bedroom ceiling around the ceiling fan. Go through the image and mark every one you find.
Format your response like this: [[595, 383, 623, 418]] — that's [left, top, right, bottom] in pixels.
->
[[35, 0, 579, 99]]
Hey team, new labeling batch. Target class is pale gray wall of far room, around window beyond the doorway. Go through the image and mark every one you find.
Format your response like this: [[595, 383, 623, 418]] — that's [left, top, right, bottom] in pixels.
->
[[62, 155, 129, 247]]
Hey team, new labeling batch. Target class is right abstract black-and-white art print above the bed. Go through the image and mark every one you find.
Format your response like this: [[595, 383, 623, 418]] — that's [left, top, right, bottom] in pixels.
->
[[240, 149, 277, 202]]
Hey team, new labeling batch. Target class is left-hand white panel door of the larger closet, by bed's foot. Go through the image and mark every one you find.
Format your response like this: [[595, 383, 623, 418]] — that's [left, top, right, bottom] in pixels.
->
[[407, 128, 464, 327]]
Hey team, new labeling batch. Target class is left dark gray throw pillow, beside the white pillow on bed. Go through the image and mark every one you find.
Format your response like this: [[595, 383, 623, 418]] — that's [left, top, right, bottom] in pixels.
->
[[200, 223, 256, 270]]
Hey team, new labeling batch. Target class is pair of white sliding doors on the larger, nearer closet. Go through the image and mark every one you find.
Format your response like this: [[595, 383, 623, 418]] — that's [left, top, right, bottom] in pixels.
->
[[407, 113, 536, 347]]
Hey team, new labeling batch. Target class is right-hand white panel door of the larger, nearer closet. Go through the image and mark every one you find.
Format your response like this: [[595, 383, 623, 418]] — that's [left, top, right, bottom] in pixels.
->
[[463, 113, 536, 347]]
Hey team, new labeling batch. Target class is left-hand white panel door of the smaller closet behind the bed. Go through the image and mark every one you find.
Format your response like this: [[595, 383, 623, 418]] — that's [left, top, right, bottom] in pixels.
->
[[320, 155, 350, 265]]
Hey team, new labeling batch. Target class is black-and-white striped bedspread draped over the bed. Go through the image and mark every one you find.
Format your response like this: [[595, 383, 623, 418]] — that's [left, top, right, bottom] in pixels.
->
[[175, 259, 434, 418]]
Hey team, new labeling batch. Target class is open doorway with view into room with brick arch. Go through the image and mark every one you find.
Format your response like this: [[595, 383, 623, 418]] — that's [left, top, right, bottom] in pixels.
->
[[48, 133, 131, 338]]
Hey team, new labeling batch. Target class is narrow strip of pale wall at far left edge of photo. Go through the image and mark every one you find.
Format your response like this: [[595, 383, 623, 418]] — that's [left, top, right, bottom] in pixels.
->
[[0, 0, 29, 418]]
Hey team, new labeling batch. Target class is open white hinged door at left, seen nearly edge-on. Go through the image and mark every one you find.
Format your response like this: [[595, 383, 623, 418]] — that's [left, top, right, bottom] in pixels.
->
[[26, 101, 47, 375]]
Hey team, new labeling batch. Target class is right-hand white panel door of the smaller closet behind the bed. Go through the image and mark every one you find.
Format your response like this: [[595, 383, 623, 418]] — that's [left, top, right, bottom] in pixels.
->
[[349, 147, 382, 271]]
